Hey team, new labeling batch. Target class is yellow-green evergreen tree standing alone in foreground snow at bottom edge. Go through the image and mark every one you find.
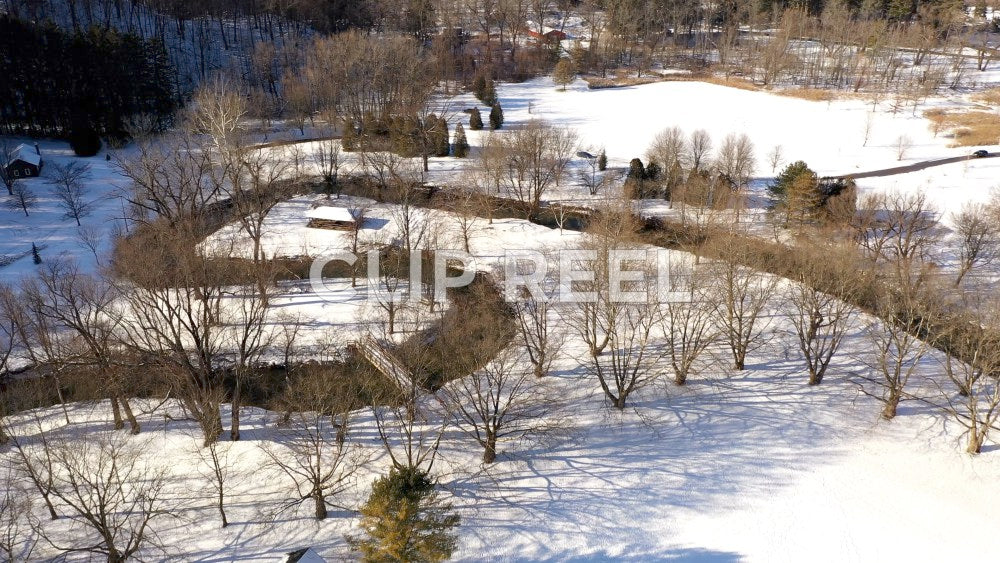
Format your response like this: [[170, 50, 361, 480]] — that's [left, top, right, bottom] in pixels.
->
[[350, 467, 459, 562]]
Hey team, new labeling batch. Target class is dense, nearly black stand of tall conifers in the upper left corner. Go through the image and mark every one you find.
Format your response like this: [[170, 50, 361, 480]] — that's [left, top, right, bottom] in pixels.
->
[[0, 16, 177, 138]]
